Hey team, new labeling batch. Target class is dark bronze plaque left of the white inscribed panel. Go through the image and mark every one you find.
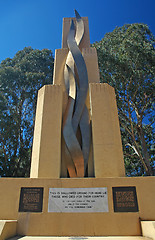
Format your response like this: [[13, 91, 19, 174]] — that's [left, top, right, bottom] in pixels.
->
[[19, 187, 43, 212]]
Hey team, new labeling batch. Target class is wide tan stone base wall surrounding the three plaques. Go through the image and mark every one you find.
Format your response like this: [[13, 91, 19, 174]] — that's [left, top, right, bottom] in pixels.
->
[[0, 177, 155, 236]]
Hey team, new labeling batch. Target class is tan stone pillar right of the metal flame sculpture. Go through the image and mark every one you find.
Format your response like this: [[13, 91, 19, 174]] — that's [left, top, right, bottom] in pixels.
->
[[90, 83, 125, 178]]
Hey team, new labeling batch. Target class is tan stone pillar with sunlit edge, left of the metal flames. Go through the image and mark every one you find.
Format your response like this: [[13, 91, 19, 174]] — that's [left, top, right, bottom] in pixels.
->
[[30, 85, 62, 178]]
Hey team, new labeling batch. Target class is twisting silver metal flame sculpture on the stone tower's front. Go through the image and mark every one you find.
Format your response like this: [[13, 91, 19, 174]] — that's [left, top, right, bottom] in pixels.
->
[[63, 10, 90, 177]]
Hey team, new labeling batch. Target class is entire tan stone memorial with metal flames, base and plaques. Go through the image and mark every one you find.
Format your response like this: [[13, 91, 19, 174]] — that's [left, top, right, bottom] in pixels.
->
[[0, 11, 155, 239]]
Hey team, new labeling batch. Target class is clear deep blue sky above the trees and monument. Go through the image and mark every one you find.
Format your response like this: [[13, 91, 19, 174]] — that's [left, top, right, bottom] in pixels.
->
[[0, 0, 155, 62]]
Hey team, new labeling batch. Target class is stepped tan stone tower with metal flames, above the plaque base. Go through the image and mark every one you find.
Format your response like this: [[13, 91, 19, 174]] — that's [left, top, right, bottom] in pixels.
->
[[30, 12, 125, 178]]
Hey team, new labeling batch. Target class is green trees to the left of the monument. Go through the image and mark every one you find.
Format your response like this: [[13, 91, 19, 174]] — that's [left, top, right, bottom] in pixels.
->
[[0, 47, 54, 177]]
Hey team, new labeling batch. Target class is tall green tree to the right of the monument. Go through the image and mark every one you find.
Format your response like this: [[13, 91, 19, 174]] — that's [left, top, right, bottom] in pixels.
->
[[93, 24, 155, 176]]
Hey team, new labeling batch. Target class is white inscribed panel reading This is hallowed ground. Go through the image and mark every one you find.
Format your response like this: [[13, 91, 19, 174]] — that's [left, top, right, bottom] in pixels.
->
[[48, 187, 108, 212]]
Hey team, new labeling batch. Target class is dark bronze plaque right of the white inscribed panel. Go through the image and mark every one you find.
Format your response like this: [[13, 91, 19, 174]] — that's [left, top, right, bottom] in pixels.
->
[[112, 187, 138, 212]]
